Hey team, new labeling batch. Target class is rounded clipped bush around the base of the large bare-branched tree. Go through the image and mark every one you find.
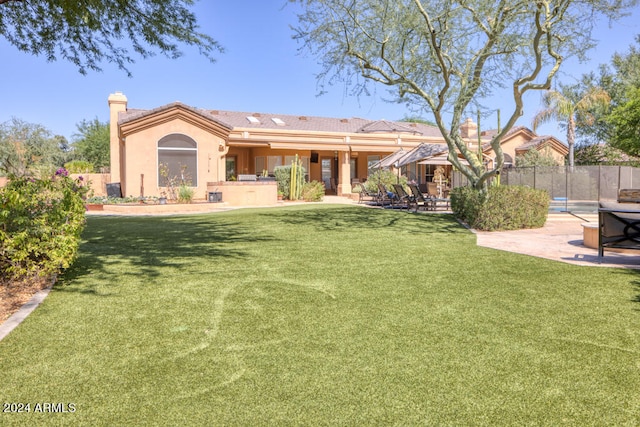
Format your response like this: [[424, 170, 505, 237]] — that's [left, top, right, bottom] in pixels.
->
[[451, 185, 549, 231]]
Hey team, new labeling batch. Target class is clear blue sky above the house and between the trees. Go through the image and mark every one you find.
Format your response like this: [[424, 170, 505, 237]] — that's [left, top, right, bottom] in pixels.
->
[[0, 0, 640, 141]]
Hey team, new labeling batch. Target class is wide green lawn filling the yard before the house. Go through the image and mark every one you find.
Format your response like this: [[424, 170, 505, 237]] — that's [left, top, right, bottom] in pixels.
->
[[0, 205, 640, 426]]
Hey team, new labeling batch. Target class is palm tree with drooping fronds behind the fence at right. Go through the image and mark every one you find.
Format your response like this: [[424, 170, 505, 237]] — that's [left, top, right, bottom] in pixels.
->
[[533, 85, 611, 167]]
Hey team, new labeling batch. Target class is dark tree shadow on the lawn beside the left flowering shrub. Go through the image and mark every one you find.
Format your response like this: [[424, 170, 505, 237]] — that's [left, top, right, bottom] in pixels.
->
[[59, 215, 275, 293]]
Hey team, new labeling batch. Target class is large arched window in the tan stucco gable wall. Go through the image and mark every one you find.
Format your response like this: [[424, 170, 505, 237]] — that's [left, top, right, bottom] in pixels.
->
[[158, 133, 198, 187]]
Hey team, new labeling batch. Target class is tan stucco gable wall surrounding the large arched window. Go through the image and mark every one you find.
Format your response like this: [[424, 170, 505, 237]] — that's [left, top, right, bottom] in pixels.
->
[[123, 118, 226, 200]]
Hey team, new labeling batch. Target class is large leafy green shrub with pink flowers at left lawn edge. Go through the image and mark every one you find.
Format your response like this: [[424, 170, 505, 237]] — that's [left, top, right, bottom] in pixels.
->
[[0, 169, 86, 279]]
